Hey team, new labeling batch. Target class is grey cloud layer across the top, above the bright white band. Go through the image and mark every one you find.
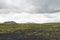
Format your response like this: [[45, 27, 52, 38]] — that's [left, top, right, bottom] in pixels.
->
[[0, 0, 60, 13]]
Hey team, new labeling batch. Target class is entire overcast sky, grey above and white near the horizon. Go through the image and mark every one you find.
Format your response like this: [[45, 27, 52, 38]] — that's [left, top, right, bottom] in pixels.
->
[[0, 0, 60, 23]]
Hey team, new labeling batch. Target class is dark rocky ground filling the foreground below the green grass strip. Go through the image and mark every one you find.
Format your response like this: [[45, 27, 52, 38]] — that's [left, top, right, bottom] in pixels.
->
[[0, 29, 60, 40]]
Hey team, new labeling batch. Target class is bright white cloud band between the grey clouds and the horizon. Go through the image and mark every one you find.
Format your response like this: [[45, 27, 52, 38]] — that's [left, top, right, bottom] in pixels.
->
[[0, 12, 60, 23]]
